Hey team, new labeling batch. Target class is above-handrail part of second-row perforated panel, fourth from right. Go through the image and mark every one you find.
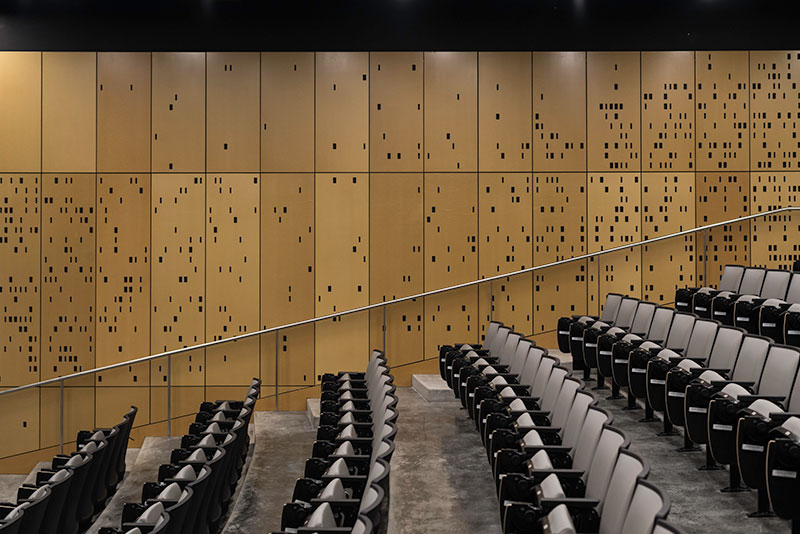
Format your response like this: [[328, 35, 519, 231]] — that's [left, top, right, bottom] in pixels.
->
[[588, 173, 642, 252]]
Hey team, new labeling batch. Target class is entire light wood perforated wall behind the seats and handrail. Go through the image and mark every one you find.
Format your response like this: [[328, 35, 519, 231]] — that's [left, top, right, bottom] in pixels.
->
[[0, 51, 800, 468]]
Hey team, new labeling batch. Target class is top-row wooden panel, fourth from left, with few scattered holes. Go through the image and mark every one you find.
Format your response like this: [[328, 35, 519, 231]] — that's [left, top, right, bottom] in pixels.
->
[[152, 52, 206, 172]]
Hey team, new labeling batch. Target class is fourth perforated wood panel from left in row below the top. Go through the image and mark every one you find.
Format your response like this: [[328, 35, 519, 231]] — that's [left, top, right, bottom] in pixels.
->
[[150, 174, 206, 390]]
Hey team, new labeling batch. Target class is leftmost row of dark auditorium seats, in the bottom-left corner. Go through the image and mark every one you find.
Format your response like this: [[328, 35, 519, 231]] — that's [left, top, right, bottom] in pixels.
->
[[0, 406, 138, 534]]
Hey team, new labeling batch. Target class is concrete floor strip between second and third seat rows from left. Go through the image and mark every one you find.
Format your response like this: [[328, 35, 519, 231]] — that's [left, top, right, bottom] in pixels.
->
[[222, 412, 316, 534]]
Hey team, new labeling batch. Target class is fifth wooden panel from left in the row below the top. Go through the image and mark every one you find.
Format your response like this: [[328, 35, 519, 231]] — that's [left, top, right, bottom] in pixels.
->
[[206, 174, 260, 386]]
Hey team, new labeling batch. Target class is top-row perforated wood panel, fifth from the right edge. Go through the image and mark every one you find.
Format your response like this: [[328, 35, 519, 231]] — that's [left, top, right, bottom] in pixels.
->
[[533, 52, 586, 171]]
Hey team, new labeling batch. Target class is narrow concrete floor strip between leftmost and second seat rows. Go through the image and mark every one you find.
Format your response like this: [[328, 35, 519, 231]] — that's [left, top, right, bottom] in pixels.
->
[[86, 436, 181, 534]]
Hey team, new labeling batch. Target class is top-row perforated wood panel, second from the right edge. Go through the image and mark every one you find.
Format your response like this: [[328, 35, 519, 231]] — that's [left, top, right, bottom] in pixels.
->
[[695, 51, 750, 172]]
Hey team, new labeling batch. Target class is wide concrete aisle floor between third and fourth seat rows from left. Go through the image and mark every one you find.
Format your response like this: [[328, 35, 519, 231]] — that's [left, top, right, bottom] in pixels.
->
[[389, 388, 501, 534]]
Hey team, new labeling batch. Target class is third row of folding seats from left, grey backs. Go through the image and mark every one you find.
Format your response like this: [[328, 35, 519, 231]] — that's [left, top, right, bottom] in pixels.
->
[[281, 351, 397, 534]]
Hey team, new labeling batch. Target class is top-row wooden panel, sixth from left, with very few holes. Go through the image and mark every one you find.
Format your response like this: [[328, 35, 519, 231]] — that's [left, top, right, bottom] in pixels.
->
[[260, 52, 314, 172]]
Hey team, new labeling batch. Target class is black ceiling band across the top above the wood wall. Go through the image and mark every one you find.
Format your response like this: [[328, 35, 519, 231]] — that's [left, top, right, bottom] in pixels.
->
[[0, 0, 800, 50]]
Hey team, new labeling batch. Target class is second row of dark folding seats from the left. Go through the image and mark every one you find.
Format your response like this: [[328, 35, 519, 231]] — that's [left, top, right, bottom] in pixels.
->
[[95, 378, 261, 534]]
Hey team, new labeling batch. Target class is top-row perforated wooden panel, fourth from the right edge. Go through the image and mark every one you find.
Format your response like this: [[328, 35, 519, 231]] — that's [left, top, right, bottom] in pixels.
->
[[586, 52, 641, 172]]
